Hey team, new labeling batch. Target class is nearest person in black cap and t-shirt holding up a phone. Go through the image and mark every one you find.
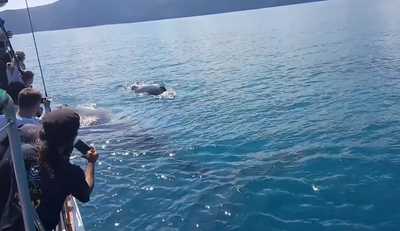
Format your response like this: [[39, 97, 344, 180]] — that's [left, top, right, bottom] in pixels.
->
[[37, 108, 99, 230]]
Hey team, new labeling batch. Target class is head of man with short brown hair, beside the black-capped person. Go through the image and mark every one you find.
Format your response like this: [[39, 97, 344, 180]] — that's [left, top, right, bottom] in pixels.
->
[[18, 88, 42, 117]]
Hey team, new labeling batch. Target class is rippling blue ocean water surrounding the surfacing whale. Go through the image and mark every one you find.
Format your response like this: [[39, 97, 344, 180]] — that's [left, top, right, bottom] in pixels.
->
[[13, 0, 400, 231]]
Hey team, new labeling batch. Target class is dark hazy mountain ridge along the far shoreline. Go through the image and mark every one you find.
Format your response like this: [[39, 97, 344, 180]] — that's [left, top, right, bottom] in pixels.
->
[[0, 0, 320, 34]]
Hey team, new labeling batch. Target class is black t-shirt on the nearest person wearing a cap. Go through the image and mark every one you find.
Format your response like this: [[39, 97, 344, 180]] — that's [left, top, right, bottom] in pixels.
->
[[37, 164, 90, 230]]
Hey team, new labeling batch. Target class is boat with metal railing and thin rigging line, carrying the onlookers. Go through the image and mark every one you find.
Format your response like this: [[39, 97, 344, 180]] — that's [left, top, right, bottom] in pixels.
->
[[0, 0, 85, 231]]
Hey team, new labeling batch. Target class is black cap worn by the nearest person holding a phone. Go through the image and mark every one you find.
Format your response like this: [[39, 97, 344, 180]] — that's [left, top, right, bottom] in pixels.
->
[[42, 108, 80, 144]]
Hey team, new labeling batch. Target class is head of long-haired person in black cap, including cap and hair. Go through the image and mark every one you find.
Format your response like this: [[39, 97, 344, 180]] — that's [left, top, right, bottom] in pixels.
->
[[39, 108, 80, 170]]
